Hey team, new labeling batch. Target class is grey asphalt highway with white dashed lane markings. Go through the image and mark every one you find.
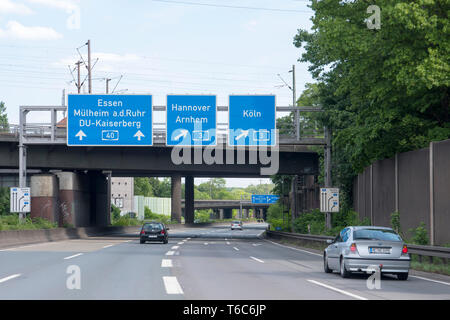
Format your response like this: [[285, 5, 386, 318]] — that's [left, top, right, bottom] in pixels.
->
[[0, 223, 450, 300]]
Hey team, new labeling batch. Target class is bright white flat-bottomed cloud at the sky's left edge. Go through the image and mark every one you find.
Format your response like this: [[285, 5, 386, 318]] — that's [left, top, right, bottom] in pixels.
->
[[0, 21, 62, 40]]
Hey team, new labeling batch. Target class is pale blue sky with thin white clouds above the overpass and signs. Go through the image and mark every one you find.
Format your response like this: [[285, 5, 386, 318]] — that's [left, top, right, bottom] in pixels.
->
[[0, 0, 312, 186]]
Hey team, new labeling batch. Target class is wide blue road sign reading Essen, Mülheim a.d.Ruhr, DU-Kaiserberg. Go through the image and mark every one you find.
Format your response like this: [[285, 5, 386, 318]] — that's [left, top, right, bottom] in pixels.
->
[[67, 94, 153, 146]]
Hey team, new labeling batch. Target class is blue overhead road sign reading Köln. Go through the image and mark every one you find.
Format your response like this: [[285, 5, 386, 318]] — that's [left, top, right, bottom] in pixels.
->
[[228, 95, 277, 146]]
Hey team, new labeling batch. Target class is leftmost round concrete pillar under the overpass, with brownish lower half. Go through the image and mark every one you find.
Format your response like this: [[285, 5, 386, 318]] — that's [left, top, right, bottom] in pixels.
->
[[30, 174, 59, 223]]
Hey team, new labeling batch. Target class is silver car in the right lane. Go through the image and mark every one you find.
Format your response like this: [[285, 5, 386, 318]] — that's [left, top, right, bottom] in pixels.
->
[[323, 226, 411, 280]]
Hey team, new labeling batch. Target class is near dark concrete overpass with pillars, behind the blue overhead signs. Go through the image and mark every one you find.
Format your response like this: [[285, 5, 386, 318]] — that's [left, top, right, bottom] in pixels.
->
[[0, 106, 325, 227]]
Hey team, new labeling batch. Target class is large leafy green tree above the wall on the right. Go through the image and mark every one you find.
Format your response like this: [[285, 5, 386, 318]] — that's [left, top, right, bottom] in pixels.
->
[[294, 0, 450, 208]]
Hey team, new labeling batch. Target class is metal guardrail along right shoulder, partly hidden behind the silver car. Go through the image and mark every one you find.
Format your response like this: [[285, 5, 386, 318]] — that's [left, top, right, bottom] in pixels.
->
[[266, 230, 450, 264]]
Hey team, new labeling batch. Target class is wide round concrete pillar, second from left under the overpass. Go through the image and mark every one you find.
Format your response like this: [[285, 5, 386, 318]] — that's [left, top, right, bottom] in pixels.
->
[[56, 172, 91, 227]]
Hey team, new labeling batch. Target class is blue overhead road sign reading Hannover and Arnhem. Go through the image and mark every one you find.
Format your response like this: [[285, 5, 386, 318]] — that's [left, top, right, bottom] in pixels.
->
[[166, 95, 217, 146]]
